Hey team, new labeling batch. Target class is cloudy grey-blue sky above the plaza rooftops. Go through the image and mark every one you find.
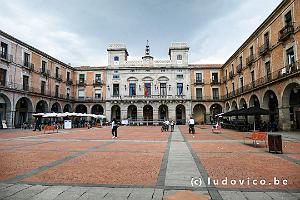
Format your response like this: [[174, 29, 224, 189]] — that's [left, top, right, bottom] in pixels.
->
[[0, 0, 281, 66]]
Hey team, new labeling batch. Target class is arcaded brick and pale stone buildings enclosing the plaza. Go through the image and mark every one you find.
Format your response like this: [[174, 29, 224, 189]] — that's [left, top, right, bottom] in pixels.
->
[[0, 0, 300, 130]]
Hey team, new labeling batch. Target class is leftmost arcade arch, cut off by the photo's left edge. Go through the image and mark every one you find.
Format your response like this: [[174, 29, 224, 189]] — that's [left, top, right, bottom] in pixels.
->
[[0, 93, 12, 128]]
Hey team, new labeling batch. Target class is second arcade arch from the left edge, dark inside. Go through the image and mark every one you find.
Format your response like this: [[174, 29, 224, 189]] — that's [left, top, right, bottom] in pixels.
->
[[15, 97, 33, 128]]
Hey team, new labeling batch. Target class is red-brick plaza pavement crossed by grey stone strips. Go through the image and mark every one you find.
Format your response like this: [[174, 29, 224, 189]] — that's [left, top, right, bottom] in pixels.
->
[[0, 126, 300, 200]]
